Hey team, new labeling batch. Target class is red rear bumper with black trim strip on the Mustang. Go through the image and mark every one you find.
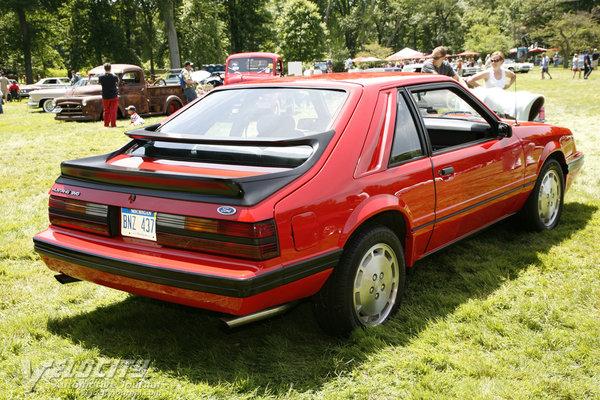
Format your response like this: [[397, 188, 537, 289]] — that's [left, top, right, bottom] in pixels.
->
[[33, 228, 341, 315]]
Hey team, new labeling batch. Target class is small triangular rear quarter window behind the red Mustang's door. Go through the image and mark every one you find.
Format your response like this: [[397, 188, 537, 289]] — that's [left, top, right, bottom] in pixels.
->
[[390, 93, 423, 165]]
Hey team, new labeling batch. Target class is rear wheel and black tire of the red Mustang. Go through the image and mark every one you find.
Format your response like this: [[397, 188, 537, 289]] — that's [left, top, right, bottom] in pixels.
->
[[313, 225, 406, 336]]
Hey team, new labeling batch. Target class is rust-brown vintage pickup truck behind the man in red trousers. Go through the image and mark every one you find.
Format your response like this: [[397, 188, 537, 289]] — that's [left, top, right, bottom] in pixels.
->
[[55, 64, 186, 121]]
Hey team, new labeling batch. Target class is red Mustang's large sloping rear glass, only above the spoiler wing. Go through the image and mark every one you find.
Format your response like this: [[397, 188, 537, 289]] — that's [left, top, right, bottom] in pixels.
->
[[158, 88, 347, 139]]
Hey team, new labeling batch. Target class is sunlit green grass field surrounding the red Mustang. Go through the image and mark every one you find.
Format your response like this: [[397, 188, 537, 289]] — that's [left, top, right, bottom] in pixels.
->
[[0, 69, 600, 399]]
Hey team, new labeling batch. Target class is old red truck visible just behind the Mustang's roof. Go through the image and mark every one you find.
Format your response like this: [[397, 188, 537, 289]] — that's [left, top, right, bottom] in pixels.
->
[[224, 52, 283, 85]]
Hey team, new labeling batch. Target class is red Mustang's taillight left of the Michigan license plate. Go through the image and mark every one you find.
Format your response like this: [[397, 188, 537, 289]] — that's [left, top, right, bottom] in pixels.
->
[[48, 196, 110, 236]]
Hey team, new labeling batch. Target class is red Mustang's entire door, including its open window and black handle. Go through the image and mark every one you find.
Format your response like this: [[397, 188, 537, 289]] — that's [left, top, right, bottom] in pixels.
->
[[411, 85, 524, 253]]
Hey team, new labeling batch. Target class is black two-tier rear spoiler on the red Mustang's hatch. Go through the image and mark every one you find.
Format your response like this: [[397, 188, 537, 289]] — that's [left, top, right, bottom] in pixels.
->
[[56, 125, 334, 206]]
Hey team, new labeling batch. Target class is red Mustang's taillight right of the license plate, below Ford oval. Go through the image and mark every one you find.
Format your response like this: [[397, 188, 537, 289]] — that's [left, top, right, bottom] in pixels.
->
[[156, 213, 279, 260]]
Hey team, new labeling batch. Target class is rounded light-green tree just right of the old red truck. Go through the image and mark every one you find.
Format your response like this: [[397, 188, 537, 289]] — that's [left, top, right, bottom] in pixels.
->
[[277, 0, 325, 61]]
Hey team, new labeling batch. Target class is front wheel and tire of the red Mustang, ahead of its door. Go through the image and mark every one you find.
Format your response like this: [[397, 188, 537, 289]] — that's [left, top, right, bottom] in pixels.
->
[[522, 159, 565, 231]]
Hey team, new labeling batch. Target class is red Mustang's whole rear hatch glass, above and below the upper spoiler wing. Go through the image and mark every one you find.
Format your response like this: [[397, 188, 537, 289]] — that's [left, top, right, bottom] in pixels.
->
[[127, 88, 347, 168]]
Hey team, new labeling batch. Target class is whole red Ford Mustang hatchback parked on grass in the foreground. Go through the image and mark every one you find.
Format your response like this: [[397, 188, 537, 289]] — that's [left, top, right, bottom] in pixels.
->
[[33, 72, 583, 334]]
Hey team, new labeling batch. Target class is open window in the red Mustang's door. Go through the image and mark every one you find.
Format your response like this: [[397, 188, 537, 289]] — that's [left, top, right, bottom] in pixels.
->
[[412, 89, 493, 152]]
